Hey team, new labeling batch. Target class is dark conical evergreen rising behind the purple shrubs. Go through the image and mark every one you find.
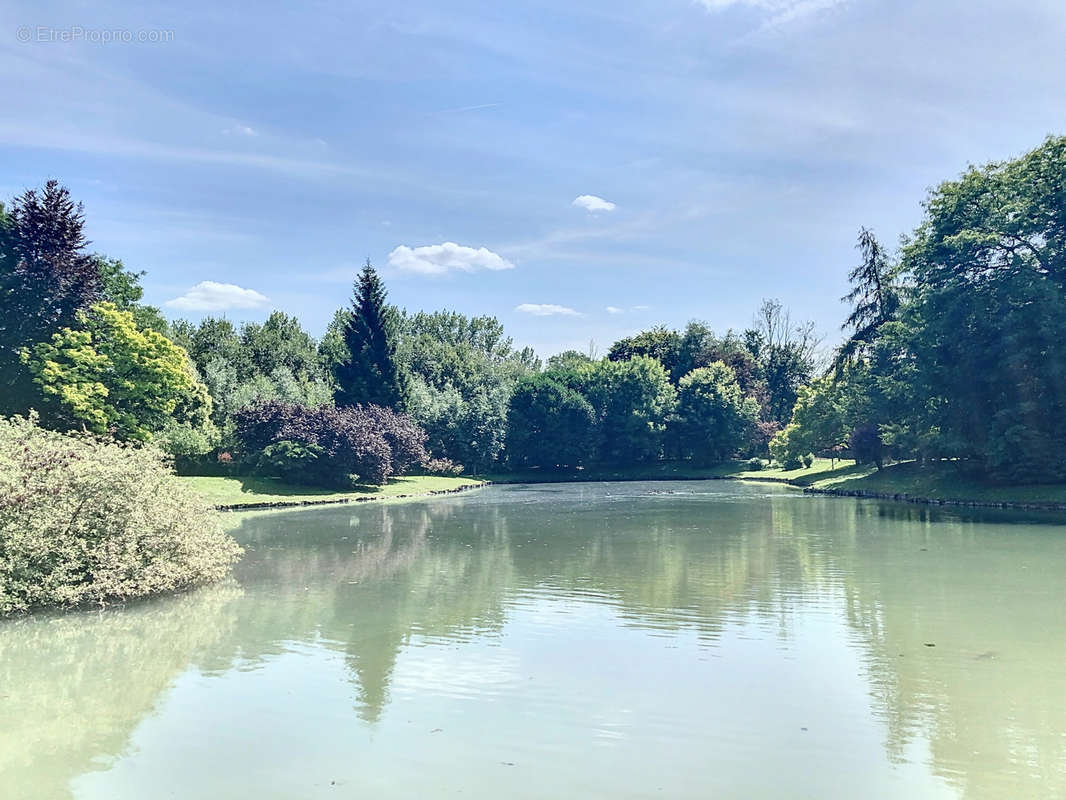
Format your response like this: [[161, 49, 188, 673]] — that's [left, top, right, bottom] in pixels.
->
[[333, 259, 405, 409]]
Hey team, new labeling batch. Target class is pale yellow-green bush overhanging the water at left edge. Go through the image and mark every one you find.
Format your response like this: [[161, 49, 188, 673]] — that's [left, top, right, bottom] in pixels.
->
[[0, 417, 241, 613]]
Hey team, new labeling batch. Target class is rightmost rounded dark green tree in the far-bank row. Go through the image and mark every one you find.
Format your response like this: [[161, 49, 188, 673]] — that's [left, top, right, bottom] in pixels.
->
[[673, 362, 759, 464]]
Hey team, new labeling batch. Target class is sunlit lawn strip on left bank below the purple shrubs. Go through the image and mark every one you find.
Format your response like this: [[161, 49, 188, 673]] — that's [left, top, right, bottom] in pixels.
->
[[181, 475, 482, 506]]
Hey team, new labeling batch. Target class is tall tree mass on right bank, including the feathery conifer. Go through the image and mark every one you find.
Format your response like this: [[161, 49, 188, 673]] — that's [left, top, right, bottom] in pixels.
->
[[777, 138, 1066, 481]]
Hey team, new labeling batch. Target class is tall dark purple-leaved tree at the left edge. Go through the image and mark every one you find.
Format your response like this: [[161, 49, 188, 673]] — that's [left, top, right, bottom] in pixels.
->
[[0, 180, 102, 414]]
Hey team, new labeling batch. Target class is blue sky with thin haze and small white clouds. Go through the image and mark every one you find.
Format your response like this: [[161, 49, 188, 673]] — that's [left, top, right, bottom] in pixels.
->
[[0, 0, 1066, 355]]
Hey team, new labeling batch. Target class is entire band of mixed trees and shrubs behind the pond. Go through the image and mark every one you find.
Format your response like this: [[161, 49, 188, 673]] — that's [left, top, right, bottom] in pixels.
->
[[0, 132, 1066, 485]]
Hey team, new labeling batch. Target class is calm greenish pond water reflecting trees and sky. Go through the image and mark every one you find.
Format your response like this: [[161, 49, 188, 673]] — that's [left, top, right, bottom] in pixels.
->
[[0, 482, 1066, 800]]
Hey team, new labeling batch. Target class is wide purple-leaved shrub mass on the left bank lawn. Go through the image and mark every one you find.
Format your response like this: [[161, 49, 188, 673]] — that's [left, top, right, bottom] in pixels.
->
[[236, 401, 426, 489]]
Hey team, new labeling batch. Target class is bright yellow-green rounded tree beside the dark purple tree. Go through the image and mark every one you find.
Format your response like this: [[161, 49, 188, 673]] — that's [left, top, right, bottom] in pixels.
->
[[22, 303, 211, 442]]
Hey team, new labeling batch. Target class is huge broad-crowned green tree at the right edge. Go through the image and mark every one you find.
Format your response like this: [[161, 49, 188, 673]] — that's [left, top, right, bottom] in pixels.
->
[[897, 137, 1066, 481]]
